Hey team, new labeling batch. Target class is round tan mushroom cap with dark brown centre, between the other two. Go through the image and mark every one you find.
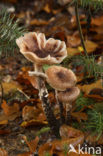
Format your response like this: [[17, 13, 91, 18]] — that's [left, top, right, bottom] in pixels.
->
[[45, 66, 77, 91]]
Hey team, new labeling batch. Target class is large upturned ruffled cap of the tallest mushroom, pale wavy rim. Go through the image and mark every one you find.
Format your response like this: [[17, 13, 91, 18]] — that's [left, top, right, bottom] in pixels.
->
[[16, 32, 67, 65]]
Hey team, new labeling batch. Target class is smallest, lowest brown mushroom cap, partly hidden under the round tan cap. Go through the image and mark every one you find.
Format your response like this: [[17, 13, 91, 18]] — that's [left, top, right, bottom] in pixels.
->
[[58, 87, 80, 103]]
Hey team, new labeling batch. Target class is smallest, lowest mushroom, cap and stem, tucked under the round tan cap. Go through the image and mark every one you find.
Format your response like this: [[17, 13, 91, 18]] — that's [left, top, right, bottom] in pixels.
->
[[58, 87, 80, 123]]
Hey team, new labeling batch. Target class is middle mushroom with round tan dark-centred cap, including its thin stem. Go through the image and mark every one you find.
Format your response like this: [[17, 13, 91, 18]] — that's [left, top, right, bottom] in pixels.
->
[[45, 66, 77, 123]]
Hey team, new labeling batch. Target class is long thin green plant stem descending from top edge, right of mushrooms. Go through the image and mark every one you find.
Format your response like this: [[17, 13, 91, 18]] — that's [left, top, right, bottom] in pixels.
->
[[75, 0, 88, 57]]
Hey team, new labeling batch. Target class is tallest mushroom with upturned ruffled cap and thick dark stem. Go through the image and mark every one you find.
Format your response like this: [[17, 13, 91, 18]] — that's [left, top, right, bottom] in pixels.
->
[[16, 32, 67, 137]]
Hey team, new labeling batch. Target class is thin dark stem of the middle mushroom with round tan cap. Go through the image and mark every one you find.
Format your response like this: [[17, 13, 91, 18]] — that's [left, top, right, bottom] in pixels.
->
[[55, 90, 65, 125]]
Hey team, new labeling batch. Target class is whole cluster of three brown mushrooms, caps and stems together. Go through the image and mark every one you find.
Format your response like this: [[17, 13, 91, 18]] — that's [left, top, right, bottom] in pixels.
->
[[16, 32, 80, 137]]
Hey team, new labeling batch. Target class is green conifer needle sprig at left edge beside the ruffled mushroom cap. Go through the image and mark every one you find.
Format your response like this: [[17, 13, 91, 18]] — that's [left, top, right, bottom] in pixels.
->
[[0, 9, 26, 56]]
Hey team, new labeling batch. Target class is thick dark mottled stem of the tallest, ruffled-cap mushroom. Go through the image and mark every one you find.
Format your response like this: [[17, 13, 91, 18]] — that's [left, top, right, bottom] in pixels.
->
[[34, 64, 60, 138]]
